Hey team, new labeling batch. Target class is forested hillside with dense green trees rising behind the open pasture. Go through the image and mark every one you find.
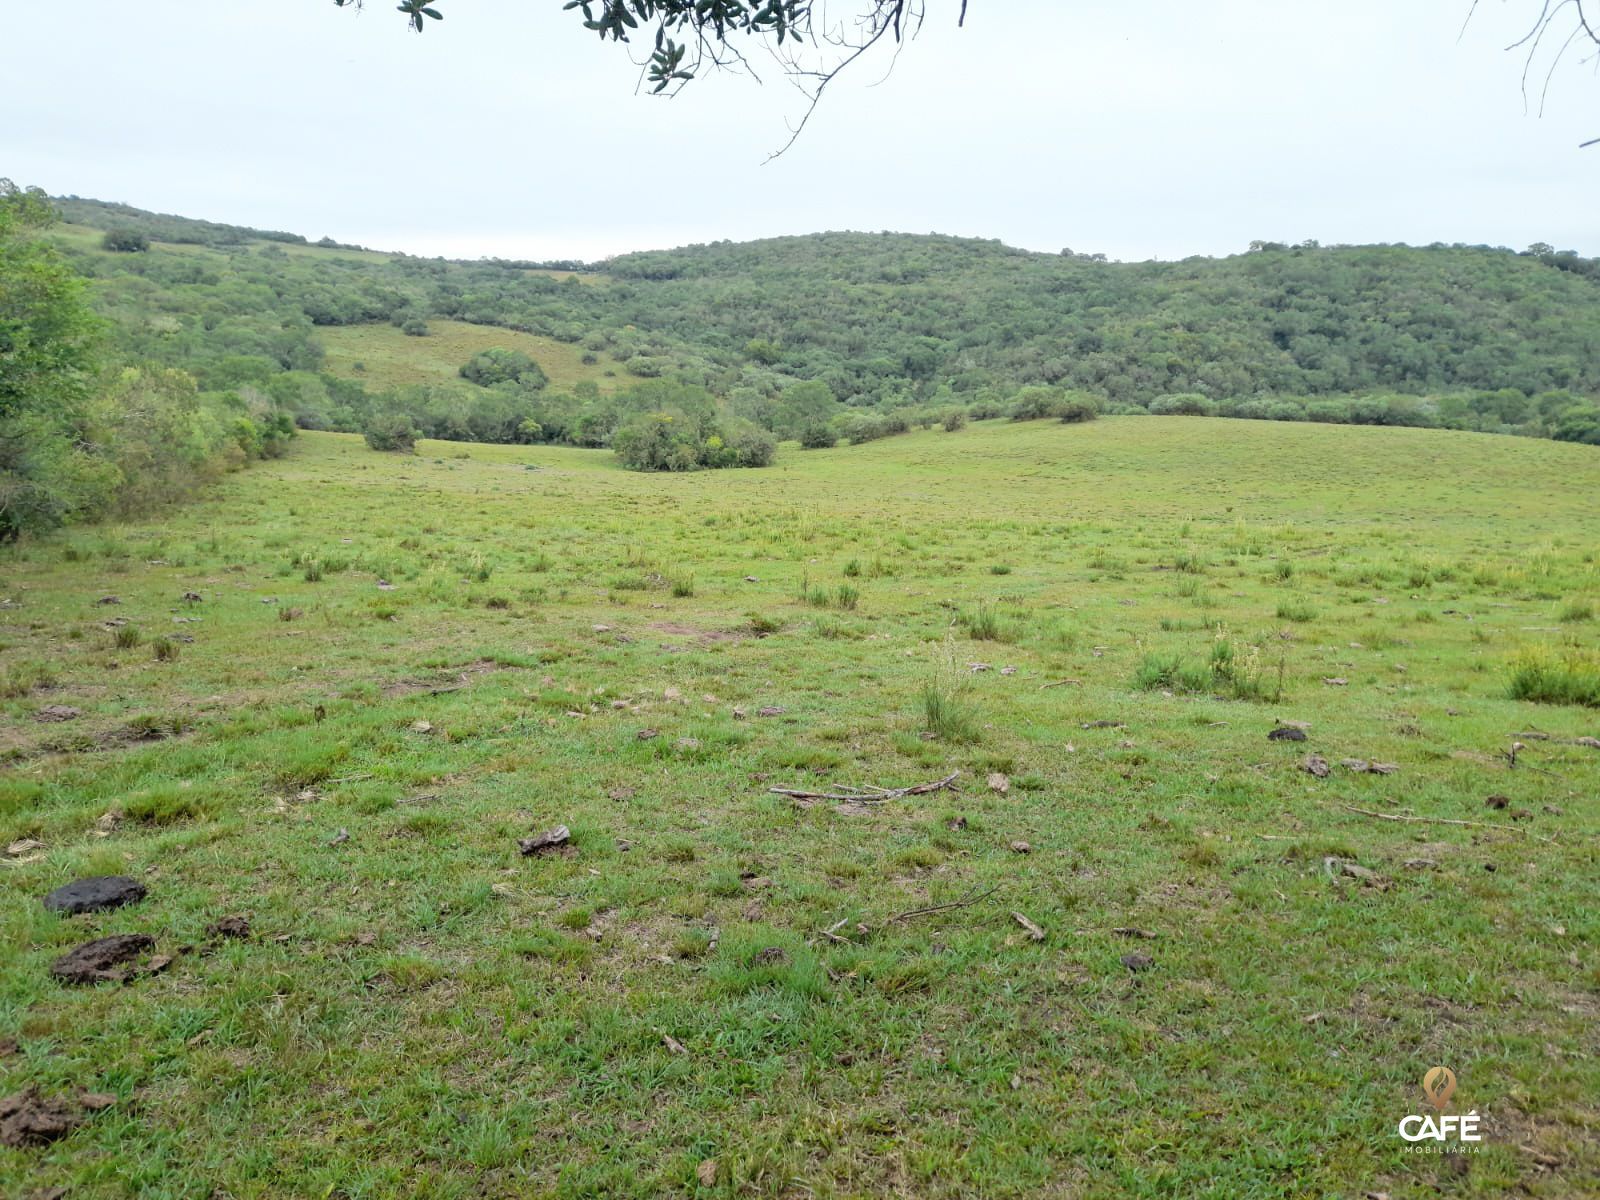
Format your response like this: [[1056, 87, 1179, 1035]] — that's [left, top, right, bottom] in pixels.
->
[[37, 198, 1600, 454]]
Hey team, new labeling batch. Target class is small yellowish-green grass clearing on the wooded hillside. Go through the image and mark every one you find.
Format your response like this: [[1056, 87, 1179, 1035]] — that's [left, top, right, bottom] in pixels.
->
[[318, 320, 624, 392]]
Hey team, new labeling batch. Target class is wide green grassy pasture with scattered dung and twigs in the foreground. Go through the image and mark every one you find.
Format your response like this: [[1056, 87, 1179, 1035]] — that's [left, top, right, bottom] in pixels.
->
[[0, 419, 1600, 1200]]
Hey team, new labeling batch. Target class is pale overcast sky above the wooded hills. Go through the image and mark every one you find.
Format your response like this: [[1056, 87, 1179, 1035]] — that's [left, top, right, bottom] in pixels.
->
[[0, 0, 1600, 259]]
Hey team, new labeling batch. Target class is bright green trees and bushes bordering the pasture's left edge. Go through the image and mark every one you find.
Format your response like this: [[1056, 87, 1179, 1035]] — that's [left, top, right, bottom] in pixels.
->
[[0, 179, 294, 541]]
